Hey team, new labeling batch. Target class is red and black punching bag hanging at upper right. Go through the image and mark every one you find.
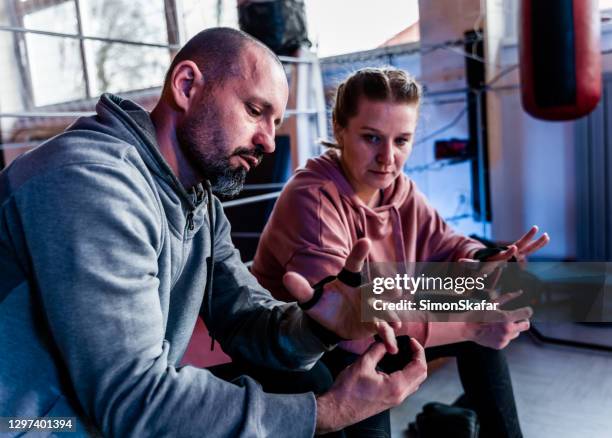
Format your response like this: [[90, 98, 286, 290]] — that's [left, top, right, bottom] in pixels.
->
[[519, 0, 602, 120]]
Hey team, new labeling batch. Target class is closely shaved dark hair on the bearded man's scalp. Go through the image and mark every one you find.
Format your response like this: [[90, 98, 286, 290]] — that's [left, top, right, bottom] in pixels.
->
[[164, 27, 282, 90]]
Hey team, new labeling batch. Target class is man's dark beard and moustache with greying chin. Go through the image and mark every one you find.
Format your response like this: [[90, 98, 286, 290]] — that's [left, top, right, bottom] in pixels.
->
[[176, 99, 263, 197]]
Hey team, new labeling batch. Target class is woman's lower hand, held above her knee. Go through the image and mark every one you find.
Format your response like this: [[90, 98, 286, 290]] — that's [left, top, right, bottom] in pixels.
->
[[464, 291, 533, 350]]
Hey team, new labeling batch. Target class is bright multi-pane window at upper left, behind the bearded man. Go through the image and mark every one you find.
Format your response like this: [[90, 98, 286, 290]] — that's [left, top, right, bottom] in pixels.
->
[[12, 0, 179, 106]]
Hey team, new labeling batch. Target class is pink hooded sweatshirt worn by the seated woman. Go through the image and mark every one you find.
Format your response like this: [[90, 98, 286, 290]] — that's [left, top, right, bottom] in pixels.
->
[[251, 151, 483, 353]]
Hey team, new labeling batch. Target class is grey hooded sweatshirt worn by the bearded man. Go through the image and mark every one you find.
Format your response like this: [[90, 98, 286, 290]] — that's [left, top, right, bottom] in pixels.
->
[[0, 94, 332, 437]]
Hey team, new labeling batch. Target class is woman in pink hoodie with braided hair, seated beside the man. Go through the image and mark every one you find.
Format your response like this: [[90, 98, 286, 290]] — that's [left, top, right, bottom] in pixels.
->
[[252, 68, 549, 438]]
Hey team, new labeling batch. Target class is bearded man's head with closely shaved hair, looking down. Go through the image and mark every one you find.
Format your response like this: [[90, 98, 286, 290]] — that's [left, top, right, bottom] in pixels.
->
[[151, 28, 289, 195]]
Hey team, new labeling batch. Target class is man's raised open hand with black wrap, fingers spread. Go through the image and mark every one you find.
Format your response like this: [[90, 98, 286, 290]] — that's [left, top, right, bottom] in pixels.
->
[[283, 238, 401, 353]]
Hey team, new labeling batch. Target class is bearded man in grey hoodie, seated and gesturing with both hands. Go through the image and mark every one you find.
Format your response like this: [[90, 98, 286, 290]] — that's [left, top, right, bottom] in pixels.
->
[[0, 28, 426, 437]]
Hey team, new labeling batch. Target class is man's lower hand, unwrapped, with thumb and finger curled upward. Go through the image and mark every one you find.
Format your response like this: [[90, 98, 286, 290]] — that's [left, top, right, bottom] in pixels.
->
[[316, 338, 427, 434]]
